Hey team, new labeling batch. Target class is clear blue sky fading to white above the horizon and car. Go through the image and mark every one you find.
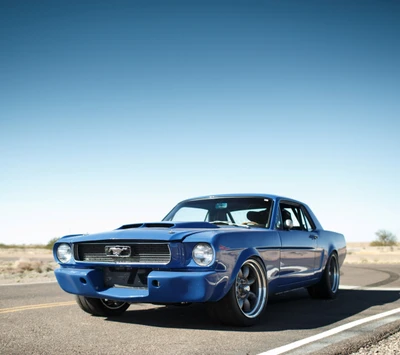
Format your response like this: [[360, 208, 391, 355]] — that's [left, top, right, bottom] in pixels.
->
[[0, 0, 400, 243]]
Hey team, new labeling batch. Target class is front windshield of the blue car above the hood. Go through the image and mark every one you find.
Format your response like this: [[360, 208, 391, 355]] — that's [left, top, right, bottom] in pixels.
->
[[164, 197, 272, 228]]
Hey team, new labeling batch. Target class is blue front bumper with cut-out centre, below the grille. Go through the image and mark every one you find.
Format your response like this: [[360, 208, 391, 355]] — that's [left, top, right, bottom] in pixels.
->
[[55, 267, 223, 303]]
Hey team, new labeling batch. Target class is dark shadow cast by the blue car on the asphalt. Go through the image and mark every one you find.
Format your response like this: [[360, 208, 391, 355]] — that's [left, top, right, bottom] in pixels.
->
[[106, 289, 400, 332]]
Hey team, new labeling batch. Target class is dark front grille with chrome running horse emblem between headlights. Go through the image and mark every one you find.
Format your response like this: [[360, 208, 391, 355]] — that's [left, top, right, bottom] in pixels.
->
[[74, 241, 171, 264]]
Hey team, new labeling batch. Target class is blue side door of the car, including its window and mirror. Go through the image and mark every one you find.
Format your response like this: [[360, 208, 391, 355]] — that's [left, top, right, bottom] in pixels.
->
[[277, 201, 318, 285]]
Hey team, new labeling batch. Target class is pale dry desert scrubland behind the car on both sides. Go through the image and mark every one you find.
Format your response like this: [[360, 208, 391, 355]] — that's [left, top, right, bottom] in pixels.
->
[[0, 243, 400, 285]]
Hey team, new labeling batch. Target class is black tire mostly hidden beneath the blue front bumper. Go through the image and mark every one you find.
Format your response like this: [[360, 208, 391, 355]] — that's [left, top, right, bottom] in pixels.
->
[[76, 296, 130, 317]]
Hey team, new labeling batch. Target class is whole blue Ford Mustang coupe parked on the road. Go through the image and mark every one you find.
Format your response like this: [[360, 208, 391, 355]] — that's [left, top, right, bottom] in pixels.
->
[[54, 194, 346, 326]]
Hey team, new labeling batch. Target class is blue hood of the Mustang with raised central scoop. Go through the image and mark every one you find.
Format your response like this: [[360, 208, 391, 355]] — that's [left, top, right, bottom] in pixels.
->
[[58, 222, 220, 243]]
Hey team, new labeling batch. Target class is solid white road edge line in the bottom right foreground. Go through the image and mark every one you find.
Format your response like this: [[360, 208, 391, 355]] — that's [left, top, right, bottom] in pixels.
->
[[258, 308, 400, 355]]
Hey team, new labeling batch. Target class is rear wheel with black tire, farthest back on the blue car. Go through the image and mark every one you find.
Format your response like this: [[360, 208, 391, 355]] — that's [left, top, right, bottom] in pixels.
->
[[307, 253, 340, 299]]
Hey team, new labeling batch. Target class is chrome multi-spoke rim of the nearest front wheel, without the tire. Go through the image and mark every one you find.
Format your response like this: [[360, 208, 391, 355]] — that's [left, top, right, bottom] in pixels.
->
[[235, 259, 267, 318]]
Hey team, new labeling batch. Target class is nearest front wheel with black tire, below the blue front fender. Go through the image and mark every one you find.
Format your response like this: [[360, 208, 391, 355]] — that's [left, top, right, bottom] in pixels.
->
[[207, 259, 268, 327]]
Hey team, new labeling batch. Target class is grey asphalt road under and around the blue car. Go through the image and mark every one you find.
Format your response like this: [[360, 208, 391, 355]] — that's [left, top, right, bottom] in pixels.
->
[[0, 264, 400, 355]]
